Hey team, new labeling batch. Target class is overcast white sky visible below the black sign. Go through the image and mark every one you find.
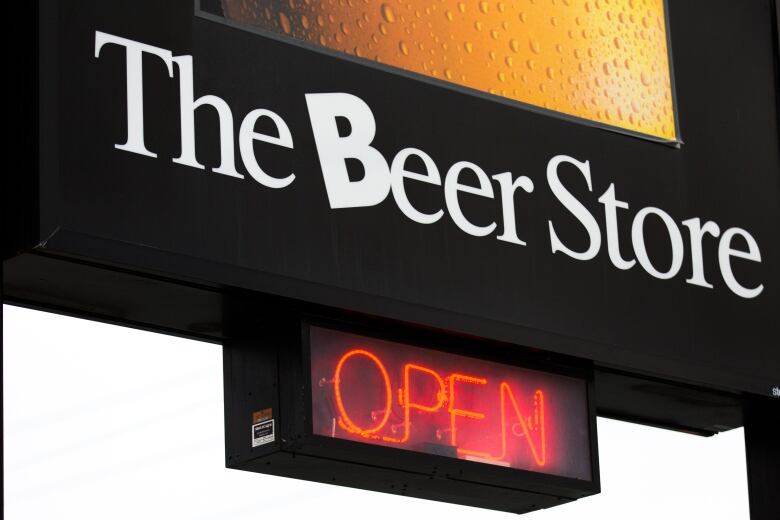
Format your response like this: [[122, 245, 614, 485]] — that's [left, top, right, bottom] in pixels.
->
[[3, 305, 748, 520]]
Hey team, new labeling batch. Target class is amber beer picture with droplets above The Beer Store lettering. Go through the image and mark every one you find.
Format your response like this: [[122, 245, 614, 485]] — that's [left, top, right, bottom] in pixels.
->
[[223, 0, 677, 141]]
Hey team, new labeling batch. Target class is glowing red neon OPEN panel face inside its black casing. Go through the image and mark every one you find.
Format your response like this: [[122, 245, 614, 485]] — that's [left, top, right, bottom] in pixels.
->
[[310, 327, 591, 480]]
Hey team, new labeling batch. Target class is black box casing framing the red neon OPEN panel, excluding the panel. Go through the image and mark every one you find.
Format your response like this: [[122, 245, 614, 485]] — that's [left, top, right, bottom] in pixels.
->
[[224, 316, 600, 513]]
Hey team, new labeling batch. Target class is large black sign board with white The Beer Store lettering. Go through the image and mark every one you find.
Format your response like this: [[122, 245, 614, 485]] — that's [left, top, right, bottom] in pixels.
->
[[3, 0, 780, 442]]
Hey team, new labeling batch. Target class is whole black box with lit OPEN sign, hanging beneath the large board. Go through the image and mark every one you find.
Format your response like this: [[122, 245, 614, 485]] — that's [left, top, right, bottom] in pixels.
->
[[225, 324, 599, 513]]
